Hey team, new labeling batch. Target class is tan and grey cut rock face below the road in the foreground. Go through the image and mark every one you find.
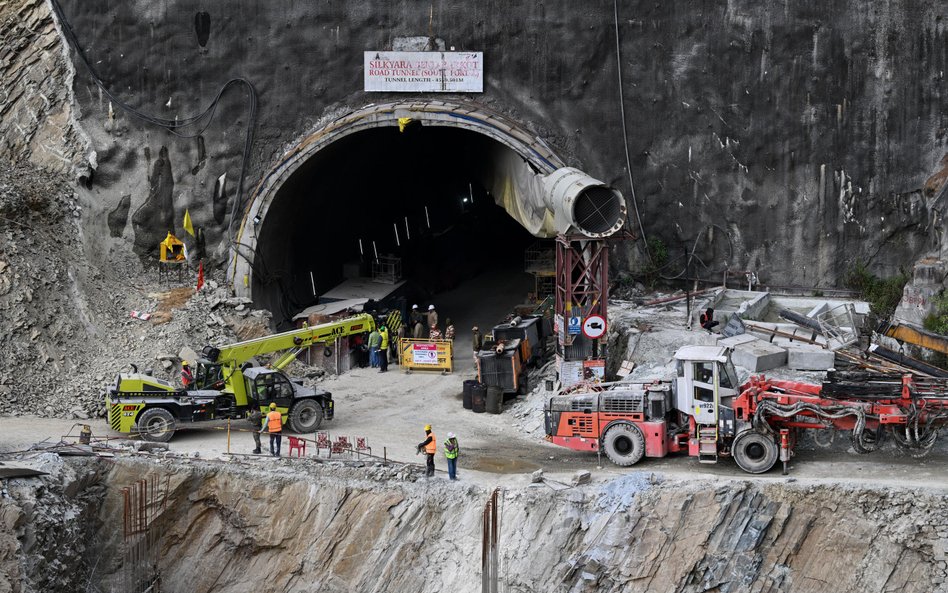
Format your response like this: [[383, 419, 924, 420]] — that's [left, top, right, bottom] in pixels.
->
[[0, 458, 948, 593]]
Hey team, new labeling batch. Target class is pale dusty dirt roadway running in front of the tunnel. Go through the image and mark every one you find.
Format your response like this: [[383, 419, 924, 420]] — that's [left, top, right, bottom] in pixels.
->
[[0, 366, 948, 489]]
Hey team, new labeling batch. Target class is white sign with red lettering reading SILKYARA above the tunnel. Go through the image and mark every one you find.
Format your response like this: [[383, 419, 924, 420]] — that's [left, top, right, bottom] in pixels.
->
[[363, 51, 484, 93]]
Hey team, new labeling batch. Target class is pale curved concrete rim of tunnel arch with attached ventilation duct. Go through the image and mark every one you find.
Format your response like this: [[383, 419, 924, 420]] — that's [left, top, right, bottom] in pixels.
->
[[228, 101, 625, 295]]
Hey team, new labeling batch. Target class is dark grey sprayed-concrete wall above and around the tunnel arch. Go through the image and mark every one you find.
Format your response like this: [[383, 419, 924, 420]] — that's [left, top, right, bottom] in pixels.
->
[[31, 0, 948, 286]]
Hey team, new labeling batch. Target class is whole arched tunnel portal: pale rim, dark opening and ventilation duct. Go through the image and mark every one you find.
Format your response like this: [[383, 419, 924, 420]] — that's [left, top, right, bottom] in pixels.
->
[[230, 101, 625, 327]]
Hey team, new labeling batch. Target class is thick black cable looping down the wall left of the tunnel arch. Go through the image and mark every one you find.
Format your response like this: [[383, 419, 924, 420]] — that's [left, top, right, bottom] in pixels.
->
[[50, 0, 257, 236]]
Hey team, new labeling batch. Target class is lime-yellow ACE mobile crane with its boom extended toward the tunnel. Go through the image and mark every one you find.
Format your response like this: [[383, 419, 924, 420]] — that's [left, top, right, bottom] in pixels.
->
[[105, 314, 375, 442]]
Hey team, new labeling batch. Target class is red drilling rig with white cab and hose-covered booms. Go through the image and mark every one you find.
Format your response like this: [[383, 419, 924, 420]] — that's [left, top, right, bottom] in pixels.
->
[[545, 346, 948, 474]]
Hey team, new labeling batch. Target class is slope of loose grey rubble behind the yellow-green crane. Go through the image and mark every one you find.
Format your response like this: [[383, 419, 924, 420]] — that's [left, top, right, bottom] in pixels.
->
[[0, 164, 270, 419]]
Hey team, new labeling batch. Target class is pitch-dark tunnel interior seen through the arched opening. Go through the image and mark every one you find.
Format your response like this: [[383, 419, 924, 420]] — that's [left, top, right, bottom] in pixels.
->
[[252, 123, 536, 327]]
